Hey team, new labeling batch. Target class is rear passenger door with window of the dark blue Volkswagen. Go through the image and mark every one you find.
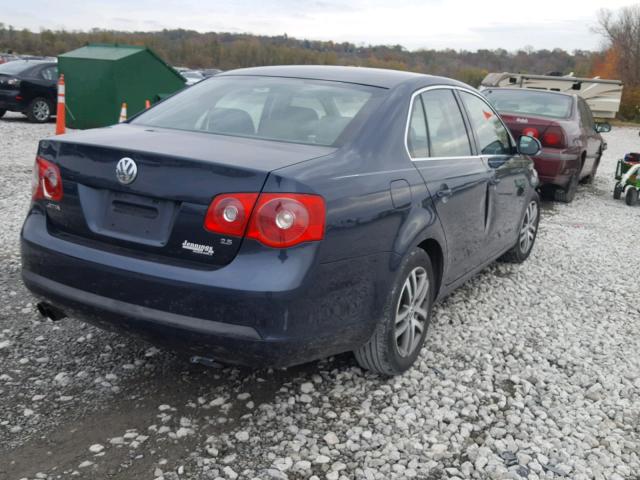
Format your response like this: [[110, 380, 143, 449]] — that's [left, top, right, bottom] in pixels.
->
[[407, 87, 489, 283]]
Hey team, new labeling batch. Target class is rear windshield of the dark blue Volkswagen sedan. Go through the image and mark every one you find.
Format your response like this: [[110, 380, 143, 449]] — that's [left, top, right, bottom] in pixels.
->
[[131, 76, 385, 146]]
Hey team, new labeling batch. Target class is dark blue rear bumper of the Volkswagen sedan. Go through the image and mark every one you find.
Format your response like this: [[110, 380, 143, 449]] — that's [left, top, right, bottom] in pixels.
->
[[21, 210, 394, 366]]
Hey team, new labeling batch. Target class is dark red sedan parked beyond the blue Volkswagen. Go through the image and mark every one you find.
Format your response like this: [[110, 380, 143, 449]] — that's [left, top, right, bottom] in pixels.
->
[[482, 88, 611, 203]]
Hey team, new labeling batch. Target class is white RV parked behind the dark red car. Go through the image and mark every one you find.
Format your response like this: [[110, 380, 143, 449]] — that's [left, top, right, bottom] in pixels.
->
[[480, 72, 622, 118]]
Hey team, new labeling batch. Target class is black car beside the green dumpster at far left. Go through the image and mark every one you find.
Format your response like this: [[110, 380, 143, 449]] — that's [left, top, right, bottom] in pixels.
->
[[0, 60, 58, 123]]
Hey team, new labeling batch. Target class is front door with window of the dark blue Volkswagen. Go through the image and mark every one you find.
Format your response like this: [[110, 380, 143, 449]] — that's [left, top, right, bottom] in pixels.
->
[[458, 90, 529, 256]]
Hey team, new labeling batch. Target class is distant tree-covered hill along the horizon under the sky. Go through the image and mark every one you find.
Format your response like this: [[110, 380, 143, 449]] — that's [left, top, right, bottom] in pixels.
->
[[0, 23, 595, 86]]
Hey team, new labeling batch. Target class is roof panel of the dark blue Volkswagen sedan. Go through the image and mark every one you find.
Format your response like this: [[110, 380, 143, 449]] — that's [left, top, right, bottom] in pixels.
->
[[216, 65, 466, 88]]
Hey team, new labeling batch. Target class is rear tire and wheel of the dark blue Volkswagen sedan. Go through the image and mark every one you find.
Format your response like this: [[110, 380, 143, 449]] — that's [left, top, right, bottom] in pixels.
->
[[354, 248, 436, 376]]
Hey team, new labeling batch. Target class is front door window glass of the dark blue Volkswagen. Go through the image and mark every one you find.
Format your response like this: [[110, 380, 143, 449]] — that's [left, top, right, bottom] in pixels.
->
[[460, 91, 512, 155]]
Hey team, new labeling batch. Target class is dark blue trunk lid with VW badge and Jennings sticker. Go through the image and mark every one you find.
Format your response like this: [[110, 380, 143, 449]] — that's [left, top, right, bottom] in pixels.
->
[[39, 125, 335, 268]]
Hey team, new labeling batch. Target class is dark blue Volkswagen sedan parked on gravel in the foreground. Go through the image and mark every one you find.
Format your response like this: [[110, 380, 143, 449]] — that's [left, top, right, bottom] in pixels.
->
[[22, 66, 540, 374]]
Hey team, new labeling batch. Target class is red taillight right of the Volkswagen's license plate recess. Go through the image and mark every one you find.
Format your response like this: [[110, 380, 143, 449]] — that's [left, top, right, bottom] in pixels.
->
[[204, 193, 325, 248]]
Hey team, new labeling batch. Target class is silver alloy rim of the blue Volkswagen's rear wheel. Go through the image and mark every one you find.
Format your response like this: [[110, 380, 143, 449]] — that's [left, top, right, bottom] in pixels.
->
[[394, 267, 430, 357]]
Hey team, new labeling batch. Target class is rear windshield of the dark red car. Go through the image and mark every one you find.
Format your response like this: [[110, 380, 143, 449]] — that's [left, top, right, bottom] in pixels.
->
[[482, 89, 573, 118]]
